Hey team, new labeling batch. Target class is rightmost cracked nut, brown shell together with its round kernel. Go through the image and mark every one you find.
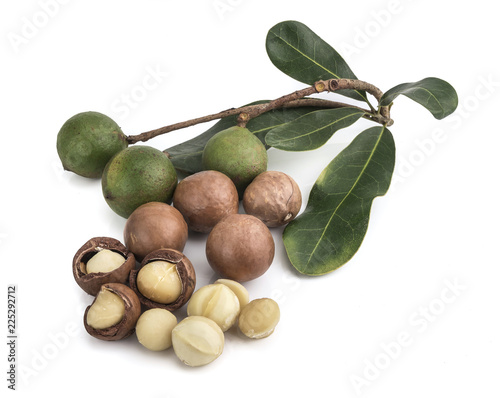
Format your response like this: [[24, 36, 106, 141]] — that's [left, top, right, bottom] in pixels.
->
[[129, 249, 196, 311]]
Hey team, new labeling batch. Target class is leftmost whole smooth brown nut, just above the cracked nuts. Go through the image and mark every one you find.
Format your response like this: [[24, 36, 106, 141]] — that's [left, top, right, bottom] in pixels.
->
[[123, 202, 188, 261]]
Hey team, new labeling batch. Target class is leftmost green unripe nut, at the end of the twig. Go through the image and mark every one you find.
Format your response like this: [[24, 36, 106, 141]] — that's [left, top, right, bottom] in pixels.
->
[[57, 112, 128, 178]]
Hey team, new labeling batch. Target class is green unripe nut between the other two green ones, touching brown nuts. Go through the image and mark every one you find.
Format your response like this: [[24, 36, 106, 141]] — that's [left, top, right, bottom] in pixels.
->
[[102, 145, 177, 218]]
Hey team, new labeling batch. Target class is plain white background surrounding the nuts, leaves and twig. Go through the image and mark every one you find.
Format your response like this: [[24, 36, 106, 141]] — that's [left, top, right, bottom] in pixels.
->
[[0, 0, 500, 398]]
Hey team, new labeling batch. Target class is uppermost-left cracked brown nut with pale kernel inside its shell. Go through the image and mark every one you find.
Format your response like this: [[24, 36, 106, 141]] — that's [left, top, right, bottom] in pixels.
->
[[73, 237, 136, 296]]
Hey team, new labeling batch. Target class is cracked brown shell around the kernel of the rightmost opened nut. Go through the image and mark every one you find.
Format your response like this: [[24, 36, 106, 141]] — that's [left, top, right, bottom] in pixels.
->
[[129, 249, 196, 311]]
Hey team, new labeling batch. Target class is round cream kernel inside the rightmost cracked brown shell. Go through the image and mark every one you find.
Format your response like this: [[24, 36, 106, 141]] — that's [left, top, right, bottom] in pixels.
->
[[137, 261, 182, 304]]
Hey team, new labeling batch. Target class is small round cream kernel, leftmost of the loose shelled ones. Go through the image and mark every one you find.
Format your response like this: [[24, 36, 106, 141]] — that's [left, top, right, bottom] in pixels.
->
[[135, 308, 177, 351]]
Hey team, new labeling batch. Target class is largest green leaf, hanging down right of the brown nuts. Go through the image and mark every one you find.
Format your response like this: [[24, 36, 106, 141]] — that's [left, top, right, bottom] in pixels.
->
[[283, 126, 396, 275]]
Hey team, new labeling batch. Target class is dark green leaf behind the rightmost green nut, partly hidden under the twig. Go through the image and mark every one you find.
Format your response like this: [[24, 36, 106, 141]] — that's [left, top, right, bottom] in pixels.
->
[[164, 101, 318, 175]]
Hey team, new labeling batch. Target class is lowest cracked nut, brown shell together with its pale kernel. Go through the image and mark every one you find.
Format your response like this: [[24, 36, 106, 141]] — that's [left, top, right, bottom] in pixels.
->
[[83, 283, 141, 341]]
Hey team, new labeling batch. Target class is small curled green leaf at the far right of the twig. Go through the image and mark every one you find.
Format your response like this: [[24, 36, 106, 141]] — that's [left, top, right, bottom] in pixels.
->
[[380, 77, 458, 119]]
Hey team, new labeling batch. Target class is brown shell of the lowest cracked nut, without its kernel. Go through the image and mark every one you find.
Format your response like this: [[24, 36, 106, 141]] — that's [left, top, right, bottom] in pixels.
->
[[83, 283, 141, 341]]
